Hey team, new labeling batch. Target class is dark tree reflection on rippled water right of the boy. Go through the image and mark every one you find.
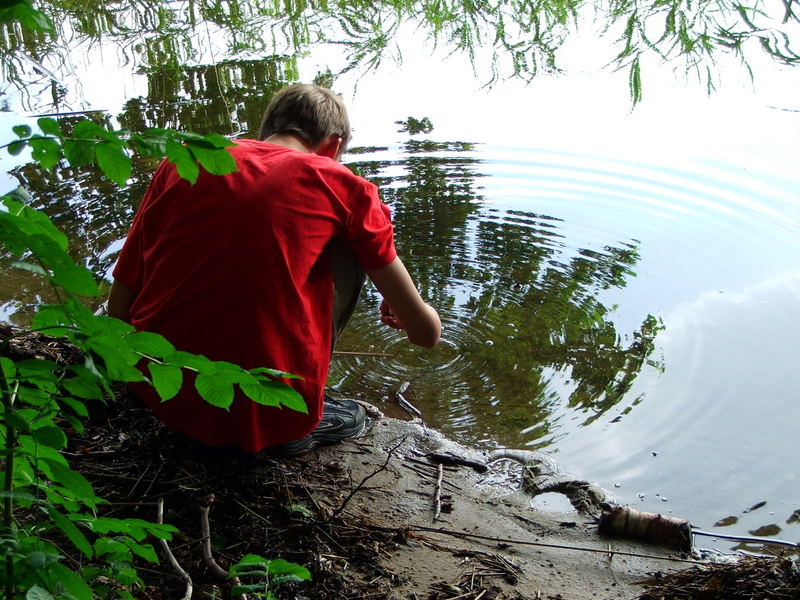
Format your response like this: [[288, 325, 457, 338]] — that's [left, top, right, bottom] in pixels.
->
[[331, 140, 664, 447]]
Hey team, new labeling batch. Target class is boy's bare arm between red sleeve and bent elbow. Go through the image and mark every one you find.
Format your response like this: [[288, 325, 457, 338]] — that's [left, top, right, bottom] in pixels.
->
[[367, 258, 442, 348]]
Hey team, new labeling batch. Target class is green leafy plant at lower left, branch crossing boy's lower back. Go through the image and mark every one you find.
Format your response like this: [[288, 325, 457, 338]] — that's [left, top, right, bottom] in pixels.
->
[[0, 169, 306, 600]]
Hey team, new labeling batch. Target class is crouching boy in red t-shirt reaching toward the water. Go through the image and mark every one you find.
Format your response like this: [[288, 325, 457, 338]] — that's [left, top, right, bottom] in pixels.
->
[[109, 85, 441, 455]]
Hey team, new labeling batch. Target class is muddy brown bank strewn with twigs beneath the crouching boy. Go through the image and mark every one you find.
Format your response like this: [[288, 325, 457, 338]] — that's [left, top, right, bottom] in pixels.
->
[[64, 395, 708, 600]]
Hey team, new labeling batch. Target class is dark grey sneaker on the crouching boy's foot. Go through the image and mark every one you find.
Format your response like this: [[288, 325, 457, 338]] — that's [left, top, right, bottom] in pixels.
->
[[264, 394, 366, 457]]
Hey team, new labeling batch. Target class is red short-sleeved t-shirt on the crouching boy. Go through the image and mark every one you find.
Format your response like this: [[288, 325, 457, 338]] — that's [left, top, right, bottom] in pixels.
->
[[114, 140, 396, 452]]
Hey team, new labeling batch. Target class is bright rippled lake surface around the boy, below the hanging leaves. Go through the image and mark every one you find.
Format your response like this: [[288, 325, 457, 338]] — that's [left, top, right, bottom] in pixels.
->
[[0, 10, 800, 551]]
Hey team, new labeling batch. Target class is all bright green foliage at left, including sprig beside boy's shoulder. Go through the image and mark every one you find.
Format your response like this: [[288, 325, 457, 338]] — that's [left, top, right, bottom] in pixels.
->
[[0, 21, 307, 600]]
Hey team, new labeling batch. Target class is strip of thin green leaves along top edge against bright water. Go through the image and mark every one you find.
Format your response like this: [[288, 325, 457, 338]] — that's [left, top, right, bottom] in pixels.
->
[[0, 0, 800, 102]]
